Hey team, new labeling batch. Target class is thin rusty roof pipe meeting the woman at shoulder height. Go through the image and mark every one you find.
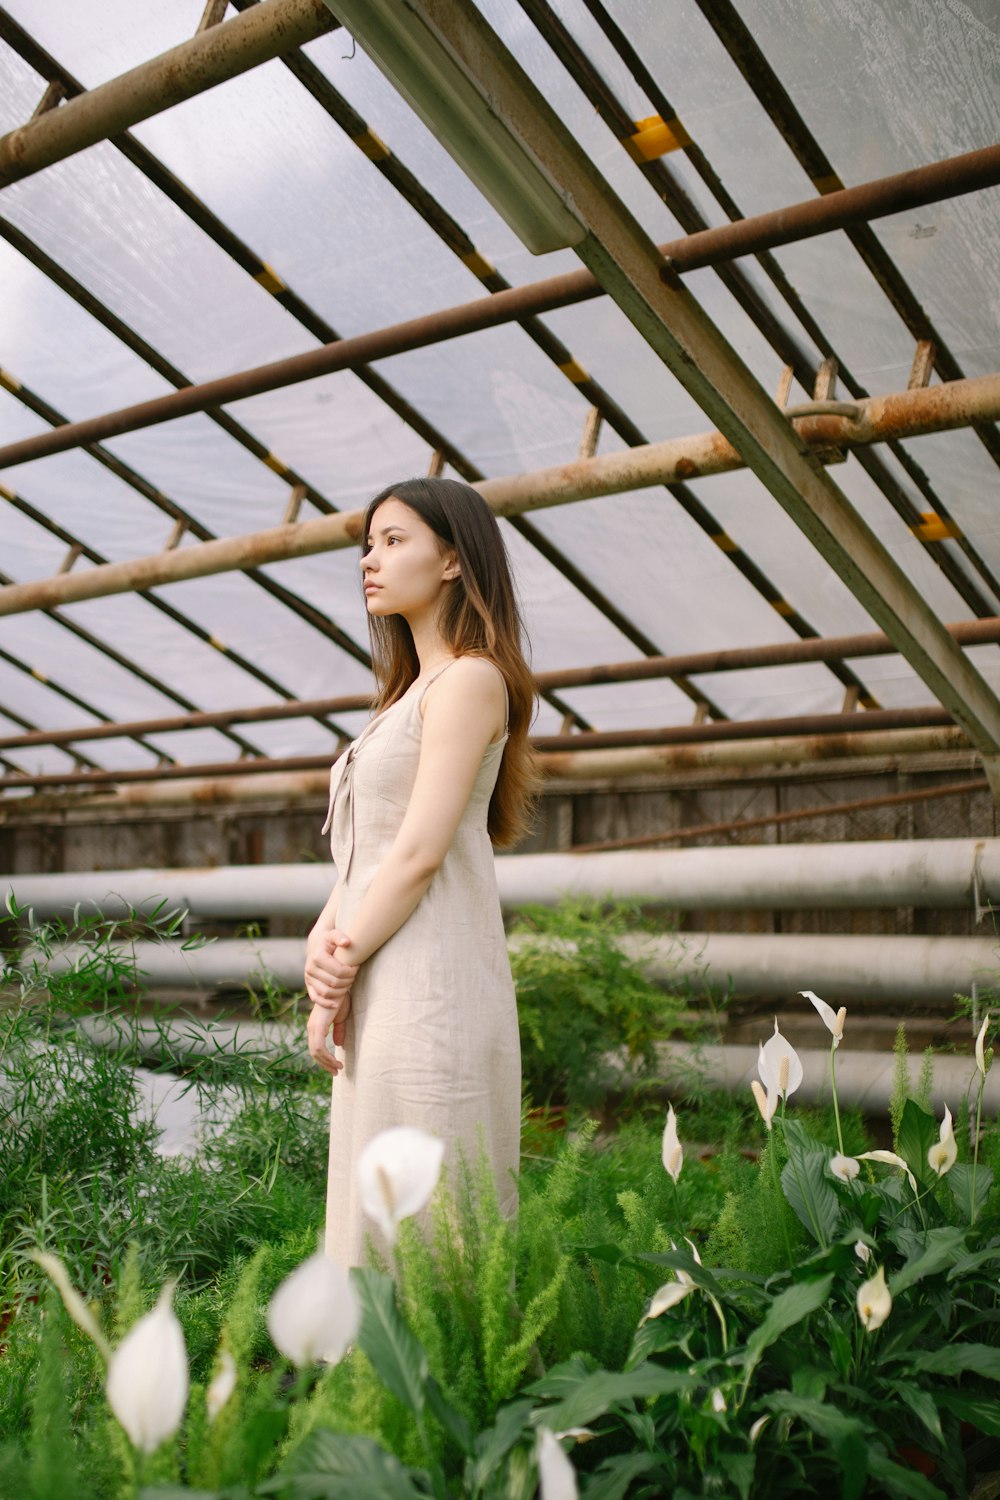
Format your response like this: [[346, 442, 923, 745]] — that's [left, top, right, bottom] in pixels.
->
[[0, 615, 1000, 750]]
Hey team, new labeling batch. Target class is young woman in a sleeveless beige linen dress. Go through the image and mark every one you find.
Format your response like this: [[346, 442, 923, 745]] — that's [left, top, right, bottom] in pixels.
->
[[306, 479, 534, 1266]]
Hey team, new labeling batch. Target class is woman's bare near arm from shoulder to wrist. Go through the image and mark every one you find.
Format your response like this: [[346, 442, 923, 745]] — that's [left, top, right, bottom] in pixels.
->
[[334, 657, 505, 965]]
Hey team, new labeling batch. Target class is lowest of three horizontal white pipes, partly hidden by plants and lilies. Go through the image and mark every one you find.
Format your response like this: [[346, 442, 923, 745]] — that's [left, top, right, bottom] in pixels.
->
[[79, 1017, 1000, 1131]]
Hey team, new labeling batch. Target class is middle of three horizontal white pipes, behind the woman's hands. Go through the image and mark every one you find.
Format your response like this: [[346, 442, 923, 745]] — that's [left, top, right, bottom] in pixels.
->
[[43, 933, 997, 1004]]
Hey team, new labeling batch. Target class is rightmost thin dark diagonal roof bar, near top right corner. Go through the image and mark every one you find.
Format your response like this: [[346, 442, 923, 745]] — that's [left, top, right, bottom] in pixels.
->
[[696, 0, 1000, 465]]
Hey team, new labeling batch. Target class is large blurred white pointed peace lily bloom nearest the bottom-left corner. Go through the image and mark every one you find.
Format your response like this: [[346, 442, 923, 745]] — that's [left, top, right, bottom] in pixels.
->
[[105, 1281, 187, 1454]]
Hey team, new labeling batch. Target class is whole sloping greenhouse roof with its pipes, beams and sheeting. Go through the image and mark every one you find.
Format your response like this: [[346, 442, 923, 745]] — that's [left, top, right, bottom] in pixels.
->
[[0, 0, 1000, 797]]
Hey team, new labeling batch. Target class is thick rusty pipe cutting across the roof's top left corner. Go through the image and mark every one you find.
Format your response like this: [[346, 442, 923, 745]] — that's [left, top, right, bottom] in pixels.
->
[[0, 0, 336, 188]]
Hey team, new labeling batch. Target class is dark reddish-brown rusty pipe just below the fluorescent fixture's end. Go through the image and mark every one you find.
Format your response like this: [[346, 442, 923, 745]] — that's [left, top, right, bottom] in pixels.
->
[[0, 144, 1000, 468]]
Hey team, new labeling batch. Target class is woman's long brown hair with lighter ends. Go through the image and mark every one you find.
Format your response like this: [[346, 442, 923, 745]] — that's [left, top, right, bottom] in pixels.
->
[[361, 479, 537, 849]]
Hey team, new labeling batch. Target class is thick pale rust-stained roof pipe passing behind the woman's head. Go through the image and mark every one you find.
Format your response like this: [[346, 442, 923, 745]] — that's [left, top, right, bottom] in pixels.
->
[[0, 375, 1000, 615]]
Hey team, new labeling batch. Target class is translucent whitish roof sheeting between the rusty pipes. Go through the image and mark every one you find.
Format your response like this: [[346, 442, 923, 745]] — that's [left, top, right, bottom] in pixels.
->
[[0, 0, 1000, 798]]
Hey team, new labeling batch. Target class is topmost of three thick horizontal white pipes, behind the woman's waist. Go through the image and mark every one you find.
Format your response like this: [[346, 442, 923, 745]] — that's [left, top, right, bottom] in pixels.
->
[[7, 839, 1000, 920]]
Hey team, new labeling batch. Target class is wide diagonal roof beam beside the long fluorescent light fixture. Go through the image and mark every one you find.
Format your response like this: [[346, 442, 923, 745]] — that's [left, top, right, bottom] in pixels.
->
[[340, 0, 1000, 792]]
